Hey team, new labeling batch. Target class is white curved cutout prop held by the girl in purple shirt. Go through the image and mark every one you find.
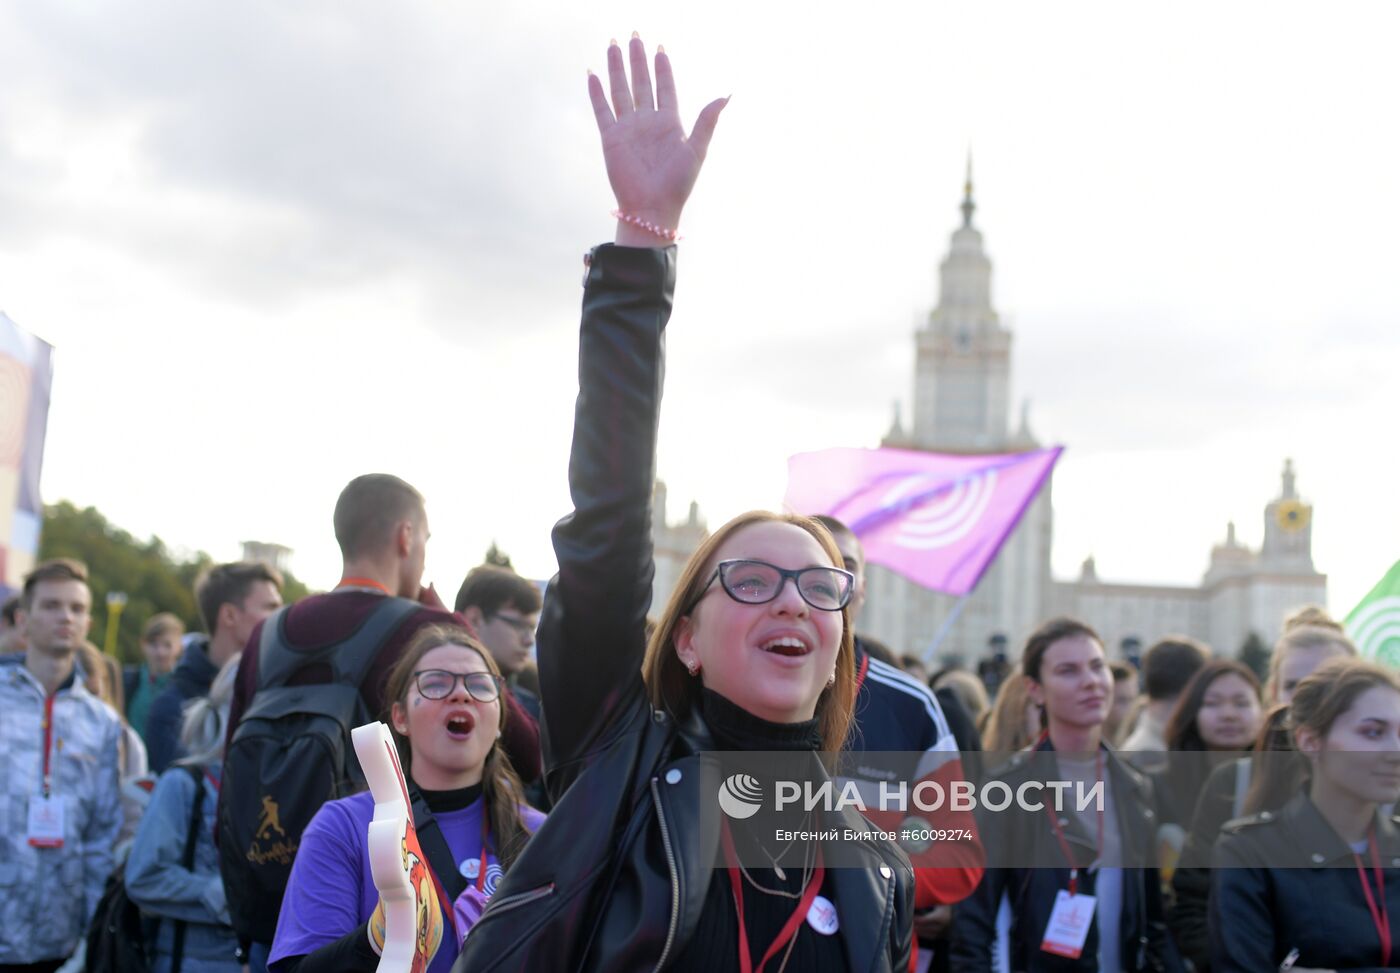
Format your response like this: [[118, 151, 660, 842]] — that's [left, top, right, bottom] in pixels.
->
[[350, 722, 442, 973]]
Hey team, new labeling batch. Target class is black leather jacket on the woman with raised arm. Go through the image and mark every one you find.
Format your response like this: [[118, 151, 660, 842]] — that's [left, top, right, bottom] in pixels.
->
[[452, 245, 913, 973]]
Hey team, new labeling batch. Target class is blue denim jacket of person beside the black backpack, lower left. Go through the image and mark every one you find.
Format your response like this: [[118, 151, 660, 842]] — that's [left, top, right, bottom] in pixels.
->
[[126, 763, 241, 973]]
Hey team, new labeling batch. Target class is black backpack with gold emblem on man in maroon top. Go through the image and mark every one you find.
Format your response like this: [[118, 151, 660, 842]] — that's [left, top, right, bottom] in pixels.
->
[[218, 598, 421, 944]]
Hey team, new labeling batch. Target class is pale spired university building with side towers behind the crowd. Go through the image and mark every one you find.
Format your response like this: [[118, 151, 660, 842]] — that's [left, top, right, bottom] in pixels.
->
[[652, 171, 1327, 664]]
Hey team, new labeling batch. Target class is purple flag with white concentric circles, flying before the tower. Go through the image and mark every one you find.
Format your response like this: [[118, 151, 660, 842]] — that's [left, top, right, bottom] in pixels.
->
[[784, 447, 1064, 595]]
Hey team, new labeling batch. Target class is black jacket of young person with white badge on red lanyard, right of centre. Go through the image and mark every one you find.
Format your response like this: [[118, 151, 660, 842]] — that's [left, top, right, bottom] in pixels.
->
[[951, 741, 1182, 973]]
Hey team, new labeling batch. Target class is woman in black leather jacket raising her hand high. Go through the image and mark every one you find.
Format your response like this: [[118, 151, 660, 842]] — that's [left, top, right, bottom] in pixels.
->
[[445, 36, 913, 973]]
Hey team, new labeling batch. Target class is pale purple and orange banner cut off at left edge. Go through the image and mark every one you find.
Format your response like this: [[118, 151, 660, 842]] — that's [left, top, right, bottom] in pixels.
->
[[0, 312, 53, 591]]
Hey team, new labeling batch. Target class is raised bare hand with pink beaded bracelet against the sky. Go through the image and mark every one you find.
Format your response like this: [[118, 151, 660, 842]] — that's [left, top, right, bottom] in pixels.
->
[[588, 35, 728, 246]]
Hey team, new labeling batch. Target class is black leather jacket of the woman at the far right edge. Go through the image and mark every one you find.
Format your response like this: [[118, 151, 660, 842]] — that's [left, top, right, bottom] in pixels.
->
[[1211, 794, 1400, 973]]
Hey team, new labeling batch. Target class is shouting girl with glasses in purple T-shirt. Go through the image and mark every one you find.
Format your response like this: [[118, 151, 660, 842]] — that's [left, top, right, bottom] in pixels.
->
[[269, 626, 543, 973]]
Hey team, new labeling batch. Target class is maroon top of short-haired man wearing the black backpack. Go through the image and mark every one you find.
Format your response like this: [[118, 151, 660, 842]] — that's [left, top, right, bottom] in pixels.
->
[[225, 588, 540, 784]]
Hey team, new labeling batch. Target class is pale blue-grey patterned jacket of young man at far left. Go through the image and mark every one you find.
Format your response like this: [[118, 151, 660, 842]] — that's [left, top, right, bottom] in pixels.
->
[[0, 658, 122, 965]]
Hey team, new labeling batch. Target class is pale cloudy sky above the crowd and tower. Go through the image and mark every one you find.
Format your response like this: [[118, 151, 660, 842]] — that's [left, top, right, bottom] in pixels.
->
[[0, 0, 1400, 624]]
